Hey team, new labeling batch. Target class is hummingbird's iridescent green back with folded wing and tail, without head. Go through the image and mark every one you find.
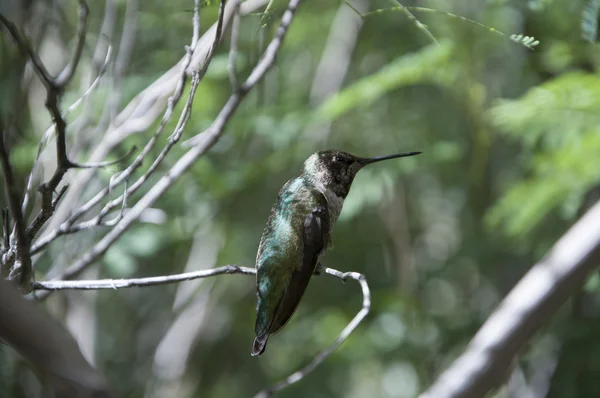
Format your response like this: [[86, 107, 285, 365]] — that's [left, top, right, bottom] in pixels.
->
[[253, 177, 329, 355]]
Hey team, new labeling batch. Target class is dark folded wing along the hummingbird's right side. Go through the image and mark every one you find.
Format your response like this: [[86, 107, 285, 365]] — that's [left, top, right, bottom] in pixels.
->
[[270, 201, 329, 334]]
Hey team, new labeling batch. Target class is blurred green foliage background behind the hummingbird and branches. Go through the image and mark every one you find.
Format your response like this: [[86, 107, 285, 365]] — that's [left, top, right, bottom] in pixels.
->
[[0, 0, 600, 398]]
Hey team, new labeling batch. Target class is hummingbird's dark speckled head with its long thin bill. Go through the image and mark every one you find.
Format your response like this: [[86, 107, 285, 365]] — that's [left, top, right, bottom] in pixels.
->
[[303, 149, 421, 198]]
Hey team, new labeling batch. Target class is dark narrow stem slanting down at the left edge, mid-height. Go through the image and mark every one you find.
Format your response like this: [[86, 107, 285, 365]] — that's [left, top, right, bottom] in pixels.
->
[[0, 131, 33, 291]]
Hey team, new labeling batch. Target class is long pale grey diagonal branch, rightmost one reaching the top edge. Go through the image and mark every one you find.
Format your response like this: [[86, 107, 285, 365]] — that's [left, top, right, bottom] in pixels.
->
[[49, 0, 301, 290]]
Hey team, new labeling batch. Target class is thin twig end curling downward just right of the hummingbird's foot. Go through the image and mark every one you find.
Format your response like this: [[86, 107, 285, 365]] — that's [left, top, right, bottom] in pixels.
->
[[254, 268, 371, 398]]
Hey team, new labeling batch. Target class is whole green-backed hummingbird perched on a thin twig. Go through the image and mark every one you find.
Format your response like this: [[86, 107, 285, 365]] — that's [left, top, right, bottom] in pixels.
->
[[252, 150, 421, 356]]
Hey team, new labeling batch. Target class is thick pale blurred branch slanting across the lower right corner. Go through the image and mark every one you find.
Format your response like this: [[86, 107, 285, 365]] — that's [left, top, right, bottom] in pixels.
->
[[421, 198, 600, 398]]
